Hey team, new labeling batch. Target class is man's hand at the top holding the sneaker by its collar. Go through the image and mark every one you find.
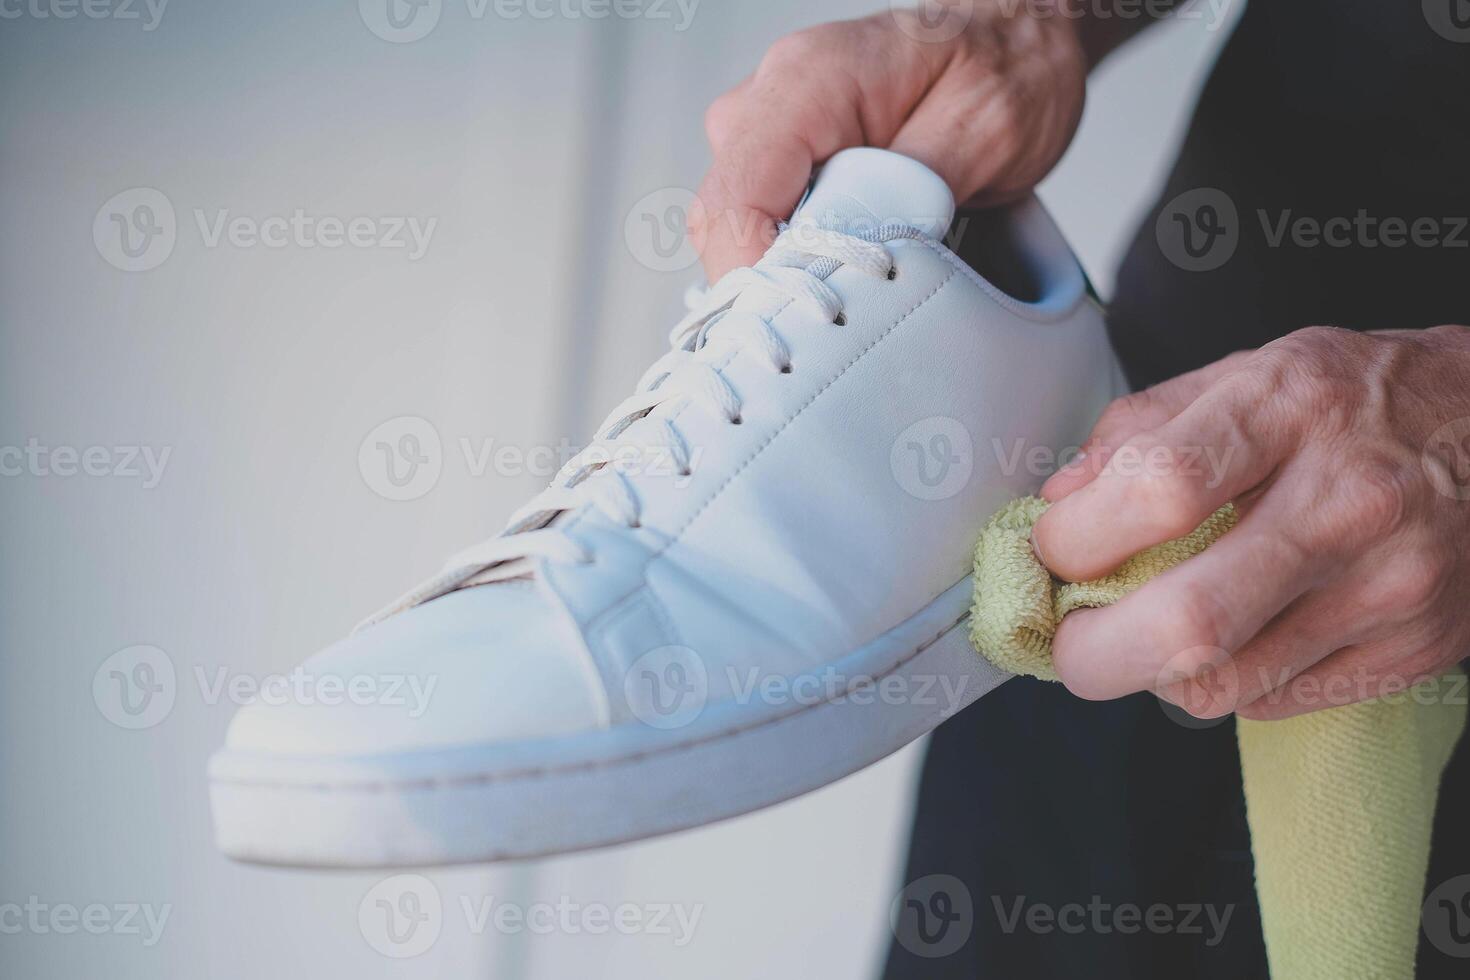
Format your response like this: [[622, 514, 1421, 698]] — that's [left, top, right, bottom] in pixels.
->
[[689, 0, 1092, 282]]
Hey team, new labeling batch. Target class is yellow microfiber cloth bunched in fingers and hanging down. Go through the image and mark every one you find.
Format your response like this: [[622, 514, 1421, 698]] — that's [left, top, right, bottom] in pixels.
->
[[970, 497, 1466, 980]]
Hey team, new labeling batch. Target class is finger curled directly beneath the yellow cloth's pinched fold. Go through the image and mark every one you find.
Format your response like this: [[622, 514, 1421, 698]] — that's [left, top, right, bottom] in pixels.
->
[[1053, 502, 1330, 711]]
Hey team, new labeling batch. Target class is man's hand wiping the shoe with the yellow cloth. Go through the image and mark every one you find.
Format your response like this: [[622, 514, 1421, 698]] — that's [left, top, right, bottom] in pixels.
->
[[1033, 326, 1470, 718]]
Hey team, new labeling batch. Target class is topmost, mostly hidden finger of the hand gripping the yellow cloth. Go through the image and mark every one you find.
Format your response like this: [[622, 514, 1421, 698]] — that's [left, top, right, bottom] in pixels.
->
[[1041, 351, 1252, 502]]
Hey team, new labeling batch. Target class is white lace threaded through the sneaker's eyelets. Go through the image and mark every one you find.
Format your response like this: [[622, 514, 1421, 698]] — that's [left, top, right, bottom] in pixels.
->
[[363, 220, 914, 626]]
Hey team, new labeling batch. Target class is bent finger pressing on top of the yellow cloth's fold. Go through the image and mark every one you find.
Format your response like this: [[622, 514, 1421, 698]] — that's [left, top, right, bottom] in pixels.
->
[[1032, 367, 1291, 582]]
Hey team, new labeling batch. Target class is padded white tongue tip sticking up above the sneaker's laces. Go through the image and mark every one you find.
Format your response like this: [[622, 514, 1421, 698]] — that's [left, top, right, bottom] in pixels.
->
[[792, 147, 954, 238]]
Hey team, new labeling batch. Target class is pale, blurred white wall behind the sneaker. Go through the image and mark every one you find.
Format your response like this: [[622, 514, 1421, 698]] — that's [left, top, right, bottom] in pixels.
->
[[0, 0, 1225, 980]]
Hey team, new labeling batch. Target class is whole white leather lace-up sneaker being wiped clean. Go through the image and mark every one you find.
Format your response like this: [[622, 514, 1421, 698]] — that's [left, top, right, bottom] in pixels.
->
[[210, 150, 1122, 865]]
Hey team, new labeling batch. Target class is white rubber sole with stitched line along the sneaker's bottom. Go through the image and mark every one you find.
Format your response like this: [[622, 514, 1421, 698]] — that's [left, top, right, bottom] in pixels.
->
[[209, 579, 1011, 867]]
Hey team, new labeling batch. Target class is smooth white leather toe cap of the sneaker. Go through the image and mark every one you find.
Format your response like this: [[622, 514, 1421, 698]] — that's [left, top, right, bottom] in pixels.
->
[[226, 582, 606, 757]]
